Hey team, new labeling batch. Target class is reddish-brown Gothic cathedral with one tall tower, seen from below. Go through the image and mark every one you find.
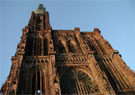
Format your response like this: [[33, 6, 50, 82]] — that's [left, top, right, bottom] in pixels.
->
[[0, 4, 135, 95]]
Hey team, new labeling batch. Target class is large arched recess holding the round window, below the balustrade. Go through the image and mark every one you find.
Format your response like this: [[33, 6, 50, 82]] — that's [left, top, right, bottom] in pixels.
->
[[60, 70, 99, 95]]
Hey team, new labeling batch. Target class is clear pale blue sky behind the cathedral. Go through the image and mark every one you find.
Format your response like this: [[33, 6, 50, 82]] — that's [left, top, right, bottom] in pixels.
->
[[0, 0, 135, 87]]
